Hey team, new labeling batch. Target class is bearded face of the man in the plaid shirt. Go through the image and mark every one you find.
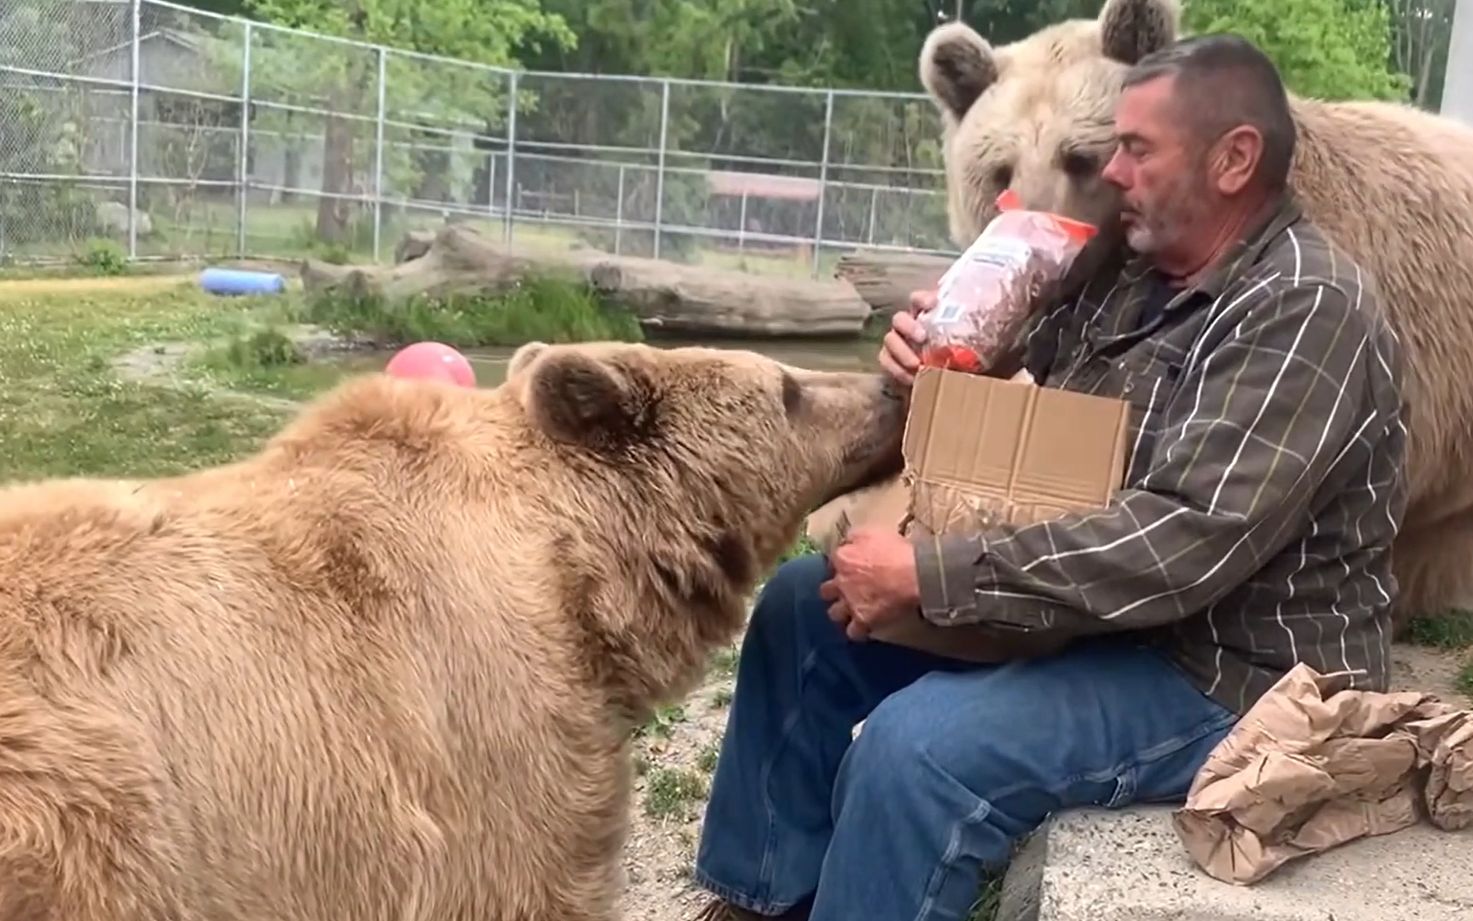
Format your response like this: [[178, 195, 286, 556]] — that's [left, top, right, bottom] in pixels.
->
[[1102, 77, 1215, 258]]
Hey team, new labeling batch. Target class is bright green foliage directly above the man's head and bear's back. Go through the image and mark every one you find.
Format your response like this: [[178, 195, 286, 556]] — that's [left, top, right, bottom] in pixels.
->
[[1184, 0, 1411, 100]]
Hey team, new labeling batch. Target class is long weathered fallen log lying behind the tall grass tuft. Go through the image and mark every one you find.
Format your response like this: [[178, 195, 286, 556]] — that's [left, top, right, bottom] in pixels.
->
[[302, 224, 871, 337]]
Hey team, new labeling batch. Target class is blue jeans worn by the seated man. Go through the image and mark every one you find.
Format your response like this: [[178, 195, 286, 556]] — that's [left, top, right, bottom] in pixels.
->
[[695, 556, 1236, 921]]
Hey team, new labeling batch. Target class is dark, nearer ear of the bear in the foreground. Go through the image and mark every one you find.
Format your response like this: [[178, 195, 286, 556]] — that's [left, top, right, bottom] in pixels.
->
[[524, 349, 653, 448]]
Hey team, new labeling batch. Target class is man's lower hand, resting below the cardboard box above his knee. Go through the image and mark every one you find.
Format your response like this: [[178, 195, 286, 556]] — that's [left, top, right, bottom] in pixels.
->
[[819, 528, 921, 640]]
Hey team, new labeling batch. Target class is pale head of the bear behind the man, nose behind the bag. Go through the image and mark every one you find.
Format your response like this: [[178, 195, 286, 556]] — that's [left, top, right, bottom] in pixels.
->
[[921, 0, 1180, 247]]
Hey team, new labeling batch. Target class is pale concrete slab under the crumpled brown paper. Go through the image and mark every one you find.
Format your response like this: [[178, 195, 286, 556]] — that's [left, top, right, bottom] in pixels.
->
[[997, 806, 1473, 921]]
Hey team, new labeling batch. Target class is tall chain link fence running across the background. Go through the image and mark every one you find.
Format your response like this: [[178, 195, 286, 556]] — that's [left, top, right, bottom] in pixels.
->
[[0, 0, 952, 274]]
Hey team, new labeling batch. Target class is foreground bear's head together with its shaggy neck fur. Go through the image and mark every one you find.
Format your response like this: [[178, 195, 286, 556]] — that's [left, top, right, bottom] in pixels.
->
[[504, 343, 907, 707]]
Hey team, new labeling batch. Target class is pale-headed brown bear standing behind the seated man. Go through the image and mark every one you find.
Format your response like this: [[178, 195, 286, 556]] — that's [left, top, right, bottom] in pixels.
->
[[919, 0, 1473, 625]]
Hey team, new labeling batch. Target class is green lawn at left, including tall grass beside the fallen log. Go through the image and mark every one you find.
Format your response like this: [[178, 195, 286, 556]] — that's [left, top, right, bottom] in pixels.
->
[[0, 269, 638, 482]]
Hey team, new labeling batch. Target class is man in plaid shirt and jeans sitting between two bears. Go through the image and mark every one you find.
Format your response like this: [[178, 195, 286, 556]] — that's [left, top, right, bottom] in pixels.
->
[[695, 35, 1405, 921]]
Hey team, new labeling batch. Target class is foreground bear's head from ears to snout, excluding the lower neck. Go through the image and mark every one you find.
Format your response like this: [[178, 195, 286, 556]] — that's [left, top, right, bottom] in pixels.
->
[[507, 342, 907, 577]]
